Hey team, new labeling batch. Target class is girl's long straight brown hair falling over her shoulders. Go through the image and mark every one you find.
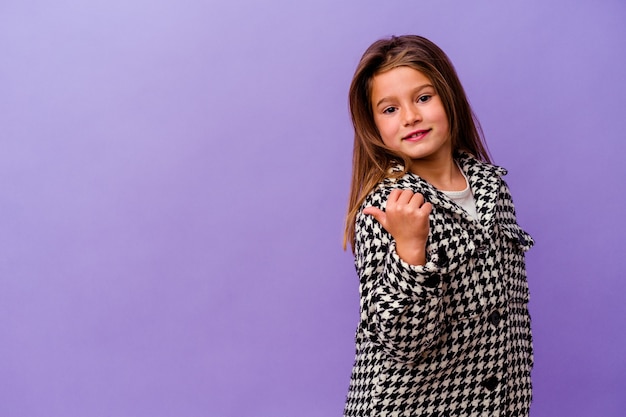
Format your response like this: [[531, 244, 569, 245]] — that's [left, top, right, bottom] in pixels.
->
[[343, 35, 491, 251]]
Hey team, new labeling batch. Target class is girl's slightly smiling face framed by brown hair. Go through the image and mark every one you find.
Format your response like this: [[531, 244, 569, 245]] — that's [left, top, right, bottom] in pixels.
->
[[371, 66, 452, 166]]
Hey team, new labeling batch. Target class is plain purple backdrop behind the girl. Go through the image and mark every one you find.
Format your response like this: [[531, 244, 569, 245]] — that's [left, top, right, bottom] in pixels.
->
[[0, 0, 626, 417]]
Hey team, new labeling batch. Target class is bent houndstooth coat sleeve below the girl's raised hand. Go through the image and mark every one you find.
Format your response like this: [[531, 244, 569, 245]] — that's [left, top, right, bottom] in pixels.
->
[[355, 188, 445, 362]]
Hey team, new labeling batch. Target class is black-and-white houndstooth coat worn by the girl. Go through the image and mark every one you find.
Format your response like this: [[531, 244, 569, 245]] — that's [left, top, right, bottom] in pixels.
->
[[344, 153, 533, 417]]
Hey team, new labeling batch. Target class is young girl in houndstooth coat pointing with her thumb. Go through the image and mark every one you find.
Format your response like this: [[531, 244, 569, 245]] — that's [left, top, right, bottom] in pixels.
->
[[344, 36, 533, 417]]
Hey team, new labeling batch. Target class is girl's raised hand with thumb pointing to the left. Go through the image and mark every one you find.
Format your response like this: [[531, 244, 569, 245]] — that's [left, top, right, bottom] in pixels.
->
[[363, 189, 433, 265]]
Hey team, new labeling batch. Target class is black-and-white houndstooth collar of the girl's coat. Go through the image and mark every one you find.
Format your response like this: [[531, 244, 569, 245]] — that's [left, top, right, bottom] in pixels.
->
[[385, 152, 507, 228]]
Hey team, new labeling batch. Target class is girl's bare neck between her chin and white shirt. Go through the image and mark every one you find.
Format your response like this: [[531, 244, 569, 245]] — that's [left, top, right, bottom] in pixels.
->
[[410, 155, 467, 191]]
